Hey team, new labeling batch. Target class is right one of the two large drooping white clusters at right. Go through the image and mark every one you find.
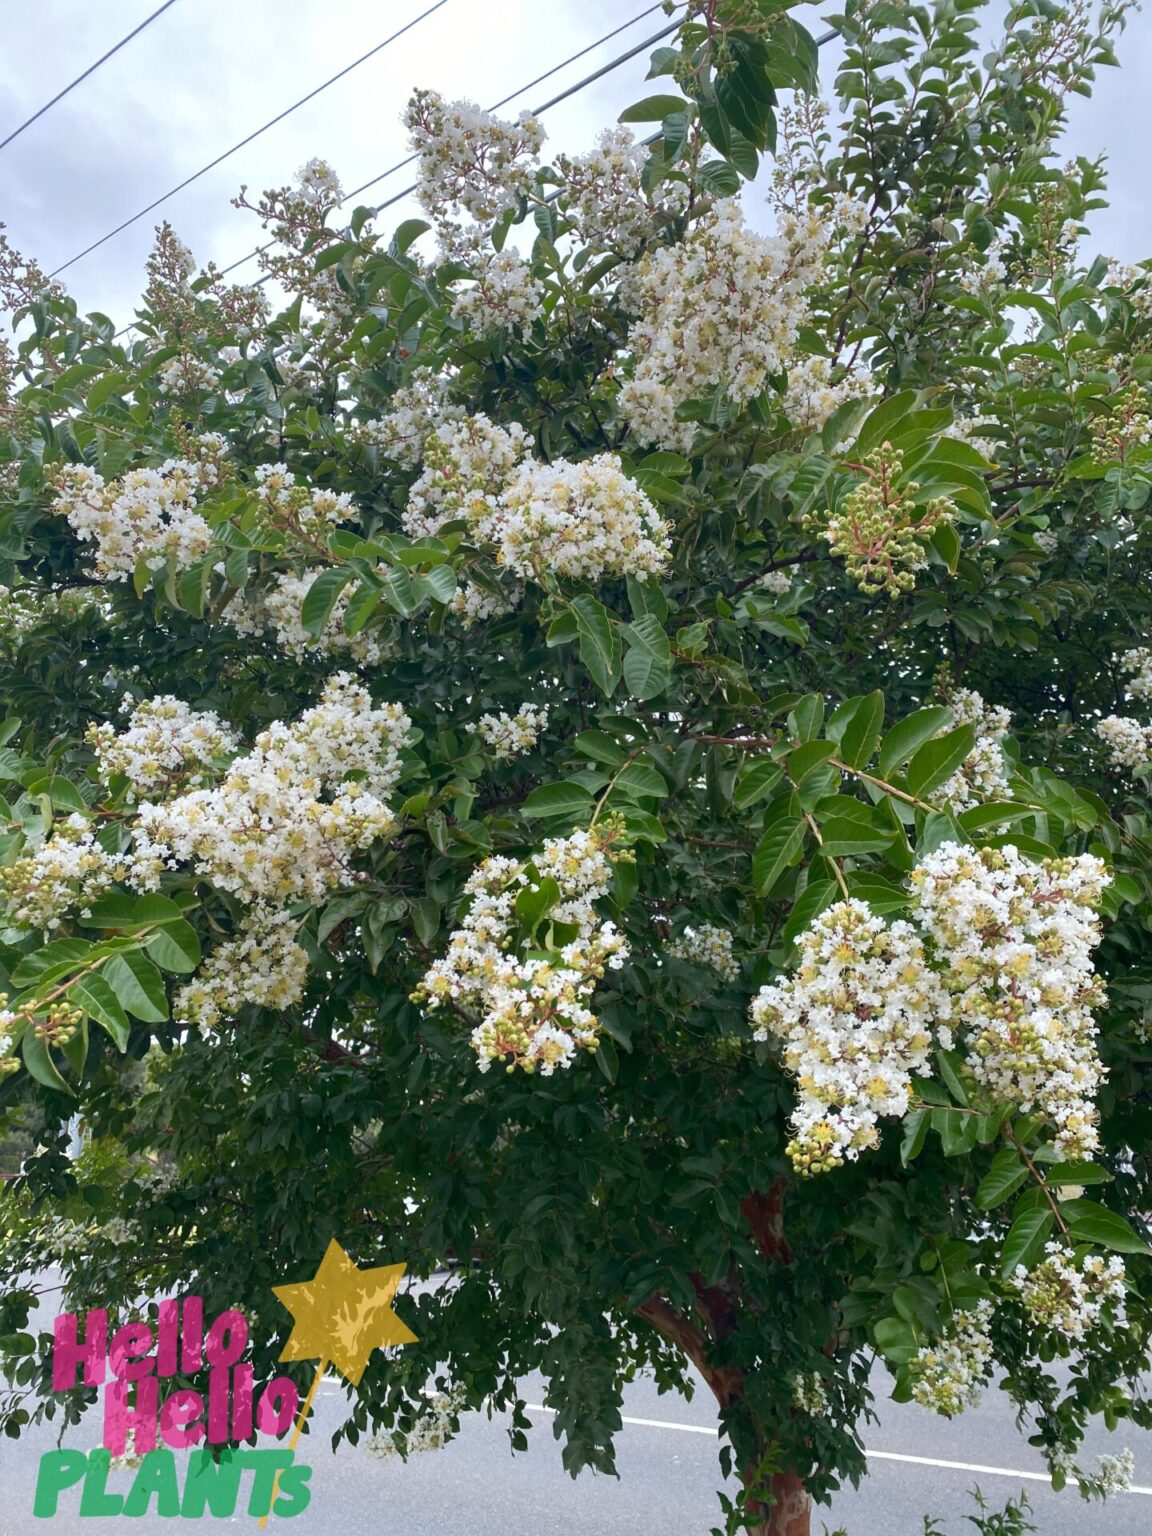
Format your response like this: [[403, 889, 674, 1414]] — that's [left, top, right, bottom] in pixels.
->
[[909, 843, 1109, 1158]]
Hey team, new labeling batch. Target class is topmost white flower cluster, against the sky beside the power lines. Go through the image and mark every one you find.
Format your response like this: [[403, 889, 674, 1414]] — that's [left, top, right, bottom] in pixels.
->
[[404, 91, 545, 260]]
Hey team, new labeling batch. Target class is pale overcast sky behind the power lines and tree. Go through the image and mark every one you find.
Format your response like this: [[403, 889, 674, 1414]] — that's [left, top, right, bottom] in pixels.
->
[[0, 0, 1152, 323]]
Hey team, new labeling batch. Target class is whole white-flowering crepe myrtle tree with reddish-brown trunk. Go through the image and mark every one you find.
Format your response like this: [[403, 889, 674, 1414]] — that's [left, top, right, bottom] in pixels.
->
[[0, 0, 1152, 1536]]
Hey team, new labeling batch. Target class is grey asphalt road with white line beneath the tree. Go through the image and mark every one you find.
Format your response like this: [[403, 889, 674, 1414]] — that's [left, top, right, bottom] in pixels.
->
[[0, 1363, 1152, 1536]]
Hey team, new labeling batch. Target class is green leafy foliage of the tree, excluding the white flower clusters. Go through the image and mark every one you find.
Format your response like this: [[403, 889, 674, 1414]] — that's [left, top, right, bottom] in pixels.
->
[[0, 0, 1152, 1533]]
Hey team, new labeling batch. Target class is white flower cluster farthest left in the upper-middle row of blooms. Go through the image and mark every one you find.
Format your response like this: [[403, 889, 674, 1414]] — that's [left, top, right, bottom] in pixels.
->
[[54, 433, 230, 581]]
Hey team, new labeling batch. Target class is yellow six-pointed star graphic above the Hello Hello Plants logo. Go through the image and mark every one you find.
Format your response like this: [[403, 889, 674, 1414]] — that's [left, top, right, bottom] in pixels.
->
[[272, 1238, 416, 1387]]
